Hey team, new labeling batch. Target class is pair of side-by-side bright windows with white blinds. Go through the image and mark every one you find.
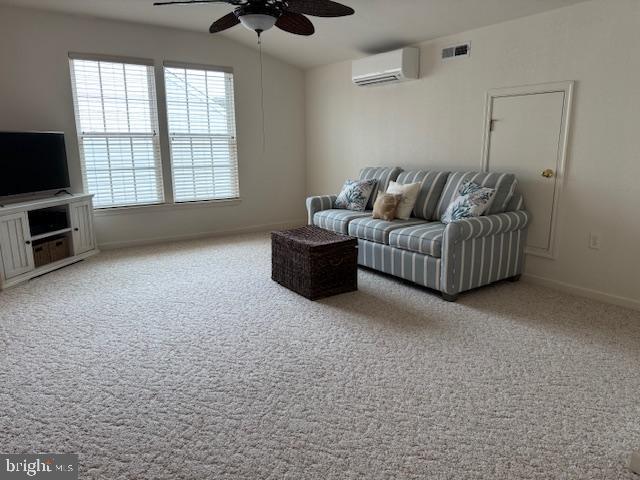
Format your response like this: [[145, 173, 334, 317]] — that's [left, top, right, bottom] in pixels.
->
[[70, 54, 240, 208]]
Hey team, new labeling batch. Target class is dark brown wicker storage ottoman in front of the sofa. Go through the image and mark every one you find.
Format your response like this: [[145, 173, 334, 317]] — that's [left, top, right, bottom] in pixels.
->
[[271, 226, 358, 300]]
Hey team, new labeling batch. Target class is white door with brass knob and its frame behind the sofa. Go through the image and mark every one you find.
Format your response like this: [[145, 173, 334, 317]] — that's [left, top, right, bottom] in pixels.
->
[[485, 82, 569, 256]]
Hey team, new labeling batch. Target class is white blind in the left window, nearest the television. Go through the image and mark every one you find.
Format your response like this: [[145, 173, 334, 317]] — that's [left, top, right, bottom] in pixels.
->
[[70, 59, 164, 208]]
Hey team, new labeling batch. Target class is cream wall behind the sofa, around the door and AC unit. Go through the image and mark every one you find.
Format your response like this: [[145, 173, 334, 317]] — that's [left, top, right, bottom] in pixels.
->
[[306, 0, 640, 306]]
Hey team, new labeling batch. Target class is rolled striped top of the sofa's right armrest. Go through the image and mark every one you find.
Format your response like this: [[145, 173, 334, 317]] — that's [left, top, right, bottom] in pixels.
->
[[444, 210, 531, 244]]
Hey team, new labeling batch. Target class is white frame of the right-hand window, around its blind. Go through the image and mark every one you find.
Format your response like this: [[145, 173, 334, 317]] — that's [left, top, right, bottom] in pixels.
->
[[158, 60, 241, 206]]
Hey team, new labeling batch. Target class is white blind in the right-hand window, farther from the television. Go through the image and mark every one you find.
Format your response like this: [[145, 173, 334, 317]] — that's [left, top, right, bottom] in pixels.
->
[[164, 65, 239, 202]]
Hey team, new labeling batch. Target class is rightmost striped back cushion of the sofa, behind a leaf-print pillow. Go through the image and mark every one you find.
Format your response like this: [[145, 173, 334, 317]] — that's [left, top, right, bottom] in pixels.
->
[[435, 172, 517, 218]]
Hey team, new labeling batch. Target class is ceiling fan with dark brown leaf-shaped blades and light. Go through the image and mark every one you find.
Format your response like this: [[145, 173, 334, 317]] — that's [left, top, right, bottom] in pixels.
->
[[154, 0, 355, 37]]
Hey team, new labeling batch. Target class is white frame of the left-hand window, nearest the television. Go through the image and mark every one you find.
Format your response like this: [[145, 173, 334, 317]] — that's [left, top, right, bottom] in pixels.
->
[[68, 52, 167, 211]]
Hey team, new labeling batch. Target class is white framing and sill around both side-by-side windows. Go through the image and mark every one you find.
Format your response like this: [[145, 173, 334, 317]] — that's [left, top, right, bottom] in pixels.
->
[[68, 52, 242, 212]]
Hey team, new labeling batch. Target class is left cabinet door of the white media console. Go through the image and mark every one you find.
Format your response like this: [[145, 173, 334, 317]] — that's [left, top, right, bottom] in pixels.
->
[[0, 213, 35, 279]]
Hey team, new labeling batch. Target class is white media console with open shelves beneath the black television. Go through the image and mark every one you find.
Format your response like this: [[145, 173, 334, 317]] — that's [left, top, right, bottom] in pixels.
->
[[0, 194, 98, 290]]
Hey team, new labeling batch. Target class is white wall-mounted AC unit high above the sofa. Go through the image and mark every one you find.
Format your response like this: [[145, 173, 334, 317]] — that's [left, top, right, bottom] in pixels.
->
[[352, 47, 420, 87]]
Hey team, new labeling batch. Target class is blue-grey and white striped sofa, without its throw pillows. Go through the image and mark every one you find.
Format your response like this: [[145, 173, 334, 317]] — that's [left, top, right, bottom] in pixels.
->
[[307, 167, 530, 301]]
